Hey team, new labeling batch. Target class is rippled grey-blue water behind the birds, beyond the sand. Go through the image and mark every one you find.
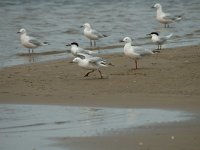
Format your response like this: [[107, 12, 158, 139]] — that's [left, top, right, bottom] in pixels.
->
[[0, 0, 200, 67]]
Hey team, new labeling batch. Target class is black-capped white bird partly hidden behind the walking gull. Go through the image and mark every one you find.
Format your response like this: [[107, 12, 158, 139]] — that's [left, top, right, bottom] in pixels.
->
[[66, 42, 97, 56]]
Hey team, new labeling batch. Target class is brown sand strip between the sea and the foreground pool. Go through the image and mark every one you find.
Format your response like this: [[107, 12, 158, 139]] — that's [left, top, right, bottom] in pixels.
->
[[0, 46, 200, 108]]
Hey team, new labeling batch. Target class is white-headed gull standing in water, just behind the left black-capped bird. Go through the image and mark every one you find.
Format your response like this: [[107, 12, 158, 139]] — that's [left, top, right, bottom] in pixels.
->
[[81, 23, 107, 46]]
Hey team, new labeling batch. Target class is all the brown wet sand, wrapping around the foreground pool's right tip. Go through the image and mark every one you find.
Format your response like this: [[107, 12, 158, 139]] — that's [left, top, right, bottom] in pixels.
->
[[0, 46, 200, 150]]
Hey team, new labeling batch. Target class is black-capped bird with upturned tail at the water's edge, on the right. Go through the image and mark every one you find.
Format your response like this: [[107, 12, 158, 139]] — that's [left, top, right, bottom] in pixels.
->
[[147, 32, 173, 50]]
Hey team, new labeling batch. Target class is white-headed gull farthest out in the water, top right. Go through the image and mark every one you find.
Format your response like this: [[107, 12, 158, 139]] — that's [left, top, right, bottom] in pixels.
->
[[152, 3, 182, 28]]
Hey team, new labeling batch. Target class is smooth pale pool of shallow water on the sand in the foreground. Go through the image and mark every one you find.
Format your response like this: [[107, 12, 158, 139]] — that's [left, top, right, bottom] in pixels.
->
[[0, 104, 193, 150]]
